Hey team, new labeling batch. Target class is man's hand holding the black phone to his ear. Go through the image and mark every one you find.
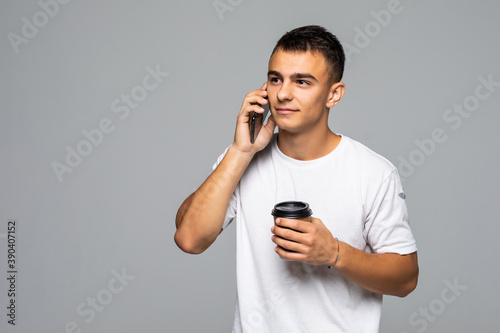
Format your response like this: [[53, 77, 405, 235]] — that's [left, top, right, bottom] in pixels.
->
[[233, 82, 276, 155]]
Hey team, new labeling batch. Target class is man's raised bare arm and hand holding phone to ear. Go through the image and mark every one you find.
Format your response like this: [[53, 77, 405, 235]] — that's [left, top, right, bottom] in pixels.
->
[[174, 83, 276, 254]]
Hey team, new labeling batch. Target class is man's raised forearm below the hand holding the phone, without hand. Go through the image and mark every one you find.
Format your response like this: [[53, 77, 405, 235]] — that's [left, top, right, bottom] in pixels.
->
[[174, 147, 252, 254]]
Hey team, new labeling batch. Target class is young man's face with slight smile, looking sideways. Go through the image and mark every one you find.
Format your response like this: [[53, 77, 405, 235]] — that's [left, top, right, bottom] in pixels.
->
[[267, 50, 331, 133]]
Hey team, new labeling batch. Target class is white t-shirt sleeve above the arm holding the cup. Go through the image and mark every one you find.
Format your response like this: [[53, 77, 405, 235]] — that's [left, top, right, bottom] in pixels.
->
[[364, 169, 417, 254]]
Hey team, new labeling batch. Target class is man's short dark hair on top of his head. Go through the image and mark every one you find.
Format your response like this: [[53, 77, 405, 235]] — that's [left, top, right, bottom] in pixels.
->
[[271, 25, 345, 83]]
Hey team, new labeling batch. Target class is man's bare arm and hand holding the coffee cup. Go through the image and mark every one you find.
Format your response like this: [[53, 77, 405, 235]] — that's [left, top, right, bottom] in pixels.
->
[[272, 218, 418, 297]]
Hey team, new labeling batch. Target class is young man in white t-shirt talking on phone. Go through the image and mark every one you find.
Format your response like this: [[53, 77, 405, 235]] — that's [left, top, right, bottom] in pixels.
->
[[175, 26, 418, 332]]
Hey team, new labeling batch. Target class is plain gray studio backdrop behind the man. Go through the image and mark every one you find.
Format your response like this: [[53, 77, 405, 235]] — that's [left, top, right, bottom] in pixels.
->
[[0, 0, 500, 333]]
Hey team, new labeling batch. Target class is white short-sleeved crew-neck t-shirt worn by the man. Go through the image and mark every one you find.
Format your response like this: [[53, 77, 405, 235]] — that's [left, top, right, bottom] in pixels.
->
[[214, 135, 417, 333]]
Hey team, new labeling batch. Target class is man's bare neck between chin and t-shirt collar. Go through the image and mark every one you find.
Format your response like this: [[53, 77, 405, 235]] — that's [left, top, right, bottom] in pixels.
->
[[278, 128, 341, 161]]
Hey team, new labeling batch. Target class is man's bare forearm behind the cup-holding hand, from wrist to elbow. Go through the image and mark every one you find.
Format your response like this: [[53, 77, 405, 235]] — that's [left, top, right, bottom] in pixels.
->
[[335, 242, 418, 297]]
